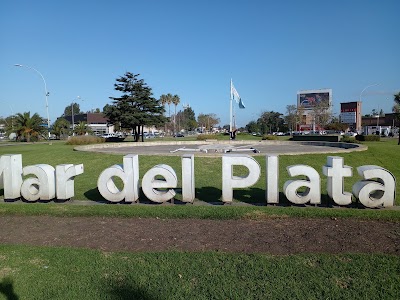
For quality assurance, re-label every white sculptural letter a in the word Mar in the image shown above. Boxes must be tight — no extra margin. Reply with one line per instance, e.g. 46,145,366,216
21,164,56,201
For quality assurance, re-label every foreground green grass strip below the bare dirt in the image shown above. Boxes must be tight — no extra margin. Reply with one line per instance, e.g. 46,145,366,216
0,246,400,299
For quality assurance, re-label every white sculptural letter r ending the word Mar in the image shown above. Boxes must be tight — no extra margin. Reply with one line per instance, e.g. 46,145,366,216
56,164,83,200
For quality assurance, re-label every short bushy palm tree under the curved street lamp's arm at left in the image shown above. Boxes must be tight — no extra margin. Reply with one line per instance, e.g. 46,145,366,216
14,111,45,142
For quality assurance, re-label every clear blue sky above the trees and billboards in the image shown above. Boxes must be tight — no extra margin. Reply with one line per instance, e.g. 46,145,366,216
0,0,400,126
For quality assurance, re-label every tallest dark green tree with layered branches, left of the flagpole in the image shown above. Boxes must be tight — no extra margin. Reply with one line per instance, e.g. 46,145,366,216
104,72,167,142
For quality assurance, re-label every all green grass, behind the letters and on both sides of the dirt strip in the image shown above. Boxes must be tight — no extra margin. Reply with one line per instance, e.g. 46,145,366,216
0,139,400,299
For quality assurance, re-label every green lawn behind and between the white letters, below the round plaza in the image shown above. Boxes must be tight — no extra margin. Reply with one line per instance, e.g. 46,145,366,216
0,139,400,216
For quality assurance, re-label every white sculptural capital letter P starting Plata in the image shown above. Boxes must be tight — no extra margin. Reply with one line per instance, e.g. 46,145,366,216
222,155,261,203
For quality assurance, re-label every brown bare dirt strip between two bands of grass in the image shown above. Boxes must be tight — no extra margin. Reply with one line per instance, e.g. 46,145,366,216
0,216,400,255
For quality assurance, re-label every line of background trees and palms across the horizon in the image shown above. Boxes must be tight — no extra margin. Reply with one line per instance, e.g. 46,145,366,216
0,72,400,143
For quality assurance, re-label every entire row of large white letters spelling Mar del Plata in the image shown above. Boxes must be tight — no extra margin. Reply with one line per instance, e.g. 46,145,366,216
0,154,396,208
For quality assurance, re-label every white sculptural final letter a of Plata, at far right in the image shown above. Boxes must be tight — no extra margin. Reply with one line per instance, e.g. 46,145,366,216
353,166,396,208
